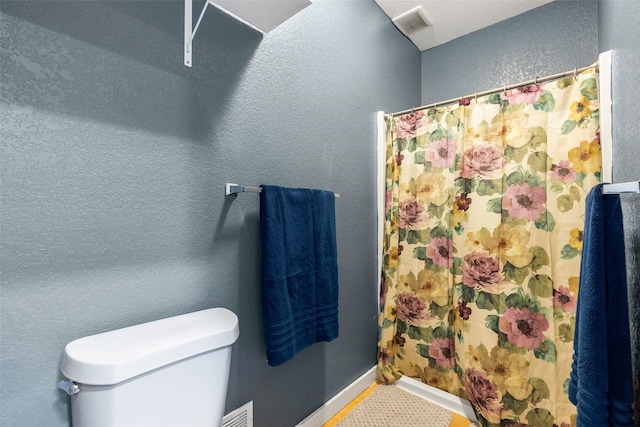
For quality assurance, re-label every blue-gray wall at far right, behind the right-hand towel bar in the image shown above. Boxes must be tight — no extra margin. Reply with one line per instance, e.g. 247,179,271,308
598,0,640,425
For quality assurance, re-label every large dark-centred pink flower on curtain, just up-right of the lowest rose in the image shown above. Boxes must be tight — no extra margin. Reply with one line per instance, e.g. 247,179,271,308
498,307,549,350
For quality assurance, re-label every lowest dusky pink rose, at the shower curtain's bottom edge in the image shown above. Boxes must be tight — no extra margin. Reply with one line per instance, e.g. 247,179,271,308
463,369,502,424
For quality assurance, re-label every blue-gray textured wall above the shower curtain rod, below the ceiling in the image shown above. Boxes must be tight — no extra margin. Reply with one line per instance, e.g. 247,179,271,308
422,0,598,105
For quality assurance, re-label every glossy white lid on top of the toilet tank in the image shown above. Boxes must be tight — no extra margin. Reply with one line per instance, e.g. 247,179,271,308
61,308,239,385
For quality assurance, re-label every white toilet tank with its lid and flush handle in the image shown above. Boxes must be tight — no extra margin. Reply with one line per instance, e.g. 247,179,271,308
61,308,239,427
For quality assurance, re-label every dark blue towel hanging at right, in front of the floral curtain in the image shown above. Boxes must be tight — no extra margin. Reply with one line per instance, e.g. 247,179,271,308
569,184,634,427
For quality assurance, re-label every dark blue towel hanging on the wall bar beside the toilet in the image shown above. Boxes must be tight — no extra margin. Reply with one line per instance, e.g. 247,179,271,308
260,185,338,366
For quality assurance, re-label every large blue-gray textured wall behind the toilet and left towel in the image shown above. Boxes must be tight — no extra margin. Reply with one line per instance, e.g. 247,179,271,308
0,0,420,427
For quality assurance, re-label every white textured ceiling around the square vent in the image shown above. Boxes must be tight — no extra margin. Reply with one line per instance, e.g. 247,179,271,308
374,0,553,51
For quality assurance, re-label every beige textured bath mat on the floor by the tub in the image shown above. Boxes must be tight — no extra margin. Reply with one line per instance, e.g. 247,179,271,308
332,384,453,427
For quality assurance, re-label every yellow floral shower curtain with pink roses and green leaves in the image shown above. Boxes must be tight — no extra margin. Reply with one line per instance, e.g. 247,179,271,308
378,68,601,427
